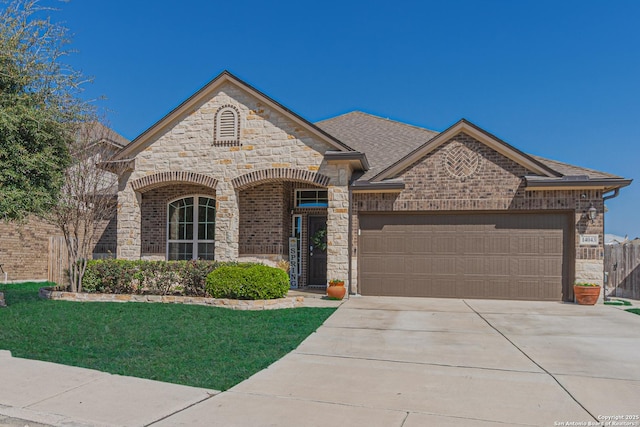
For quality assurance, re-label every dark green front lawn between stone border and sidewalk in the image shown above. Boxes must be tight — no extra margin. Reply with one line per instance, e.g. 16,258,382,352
0,283,335,390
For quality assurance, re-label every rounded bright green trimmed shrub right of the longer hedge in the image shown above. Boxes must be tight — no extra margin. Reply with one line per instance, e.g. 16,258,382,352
207,264,289,300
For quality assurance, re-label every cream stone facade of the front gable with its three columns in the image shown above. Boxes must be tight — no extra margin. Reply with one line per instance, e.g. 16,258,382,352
118,83,351,288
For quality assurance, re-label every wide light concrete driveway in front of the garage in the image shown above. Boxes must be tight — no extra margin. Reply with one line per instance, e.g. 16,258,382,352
161,297,640,427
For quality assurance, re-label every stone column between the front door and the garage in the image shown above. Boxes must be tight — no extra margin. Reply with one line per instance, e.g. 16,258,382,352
327,164,351,286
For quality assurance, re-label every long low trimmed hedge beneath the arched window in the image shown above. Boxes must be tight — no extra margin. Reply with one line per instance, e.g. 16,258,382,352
82,259,220,296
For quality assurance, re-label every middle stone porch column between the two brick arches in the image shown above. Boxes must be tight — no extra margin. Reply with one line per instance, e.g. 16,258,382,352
215,182,240,261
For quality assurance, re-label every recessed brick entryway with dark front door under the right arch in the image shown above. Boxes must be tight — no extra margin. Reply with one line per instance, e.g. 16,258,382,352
236,169,329,288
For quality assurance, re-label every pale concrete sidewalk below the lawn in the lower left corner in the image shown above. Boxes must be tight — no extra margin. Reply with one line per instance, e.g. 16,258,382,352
0,351,218,426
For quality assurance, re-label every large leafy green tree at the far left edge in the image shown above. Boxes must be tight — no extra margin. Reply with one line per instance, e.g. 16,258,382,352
0,0,95,220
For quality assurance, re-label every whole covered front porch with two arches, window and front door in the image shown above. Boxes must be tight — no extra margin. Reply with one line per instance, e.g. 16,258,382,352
118,168,348,288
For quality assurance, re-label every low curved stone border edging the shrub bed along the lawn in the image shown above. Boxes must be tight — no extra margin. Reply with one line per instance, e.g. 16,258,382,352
38,287,304,310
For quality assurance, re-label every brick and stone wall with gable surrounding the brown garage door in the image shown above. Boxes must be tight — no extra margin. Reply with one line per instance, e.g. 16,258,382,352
351,133,604,291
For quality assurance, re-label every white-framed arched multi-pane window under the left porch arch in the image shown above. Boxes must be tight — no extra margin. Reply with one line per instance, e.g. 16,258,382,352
167,196,216,260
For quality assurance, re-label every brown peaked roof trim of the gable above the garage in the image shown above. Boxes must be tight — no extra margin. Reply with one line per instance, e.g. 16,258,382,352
370,119,562,182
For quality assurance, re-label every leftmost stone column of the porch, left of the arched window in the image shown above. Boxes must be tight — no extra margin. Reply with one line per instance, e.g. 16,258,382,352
117,179,142,260
